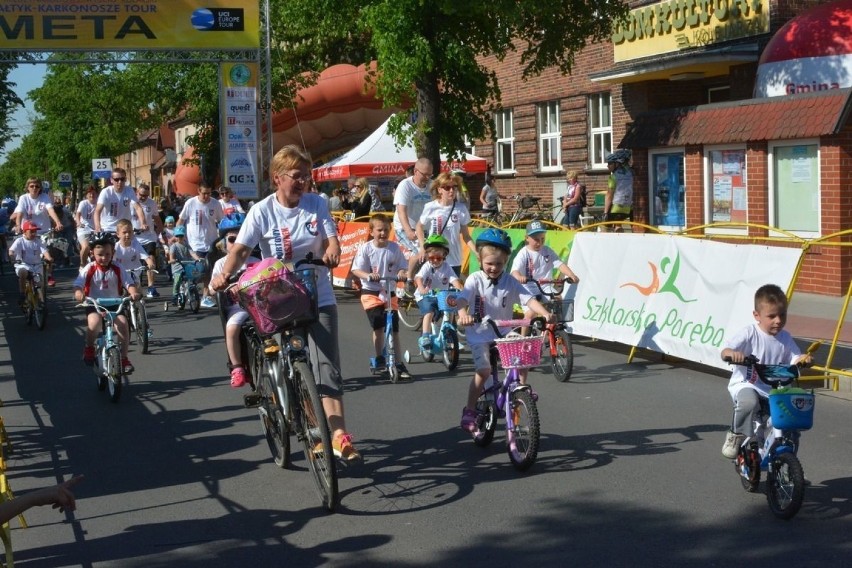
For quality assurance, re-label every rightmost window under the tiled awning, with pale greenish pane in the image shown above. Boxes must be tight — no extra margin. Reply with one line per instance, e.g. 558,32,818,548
769,141,820,237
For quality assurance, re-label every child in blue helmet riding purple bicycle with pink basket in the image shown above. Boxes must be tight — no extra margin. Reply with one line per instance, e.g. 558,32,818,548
457,229,554,432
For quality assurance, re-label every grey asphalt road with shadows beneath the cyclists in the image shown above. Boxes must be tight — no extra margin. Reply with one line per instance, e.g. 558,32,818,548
0,273,852,568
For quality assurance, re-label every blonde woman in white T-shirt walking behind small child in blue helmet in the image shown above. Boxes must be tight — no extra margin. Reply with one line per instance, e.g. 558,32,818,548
415,172,476,276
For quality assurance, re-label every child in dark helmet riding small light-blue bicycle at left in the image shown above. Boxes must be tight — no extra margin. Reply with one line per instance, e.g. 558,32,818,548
74,232,142,375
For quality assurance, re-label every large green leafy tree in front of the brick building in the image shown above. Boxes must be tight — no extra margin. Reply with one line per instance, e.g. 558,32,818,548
273,0,627,169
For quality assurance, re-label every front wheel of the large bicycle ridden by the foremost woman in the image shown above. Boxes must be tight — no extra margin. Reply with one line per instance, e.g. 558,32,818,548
295,361,338,511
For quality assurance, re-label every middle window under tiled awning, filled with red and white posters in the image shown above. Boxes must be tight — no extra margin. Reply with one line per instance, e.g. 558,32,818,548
704,147,748,233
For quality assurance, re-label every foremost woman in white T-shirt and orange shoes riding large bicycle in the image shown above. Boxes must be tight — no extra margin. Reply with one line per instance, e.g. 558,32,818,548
211,145,361,461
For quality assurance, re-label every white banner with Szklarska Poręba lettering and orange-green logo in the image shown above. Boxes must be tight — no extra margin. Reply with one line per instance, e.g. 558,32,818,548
568,232,802,368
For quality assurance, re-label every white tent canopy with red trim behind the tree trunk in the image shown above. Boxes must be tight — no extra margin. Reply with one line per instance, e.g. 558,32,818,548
313,119,488,182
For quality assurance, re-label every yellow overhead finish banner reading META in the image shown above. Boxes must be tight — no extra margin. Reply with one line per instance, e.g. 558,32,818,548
0,0,260,51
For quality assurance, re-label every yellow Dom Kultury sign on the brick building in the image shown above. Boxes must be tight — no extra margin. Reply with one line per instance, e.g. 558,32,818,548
612,0,769,63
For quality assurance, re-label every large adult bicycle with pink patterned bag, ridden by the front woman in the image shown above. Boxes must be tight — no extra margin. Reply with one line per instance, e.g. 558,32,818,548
229,258,339,511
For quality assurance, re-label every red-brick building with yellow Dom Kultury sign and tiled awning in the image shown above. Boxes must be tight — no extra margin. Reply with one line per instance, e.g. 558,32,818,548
474,0,852,295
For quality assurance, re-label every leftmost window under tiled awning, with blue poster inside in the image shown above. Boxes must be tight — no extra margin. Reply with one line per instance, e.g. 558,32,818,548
650,153,686,229
